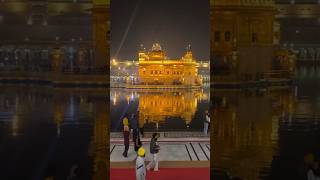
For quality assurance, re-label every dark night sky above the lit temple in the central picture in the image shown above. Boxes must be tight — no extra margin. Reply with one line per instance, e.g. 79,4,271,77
111,0,210,60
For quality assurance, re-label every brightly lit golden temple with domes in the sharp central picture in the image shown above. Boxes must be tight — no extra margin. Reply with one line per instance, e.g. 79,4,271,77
139,43,201,86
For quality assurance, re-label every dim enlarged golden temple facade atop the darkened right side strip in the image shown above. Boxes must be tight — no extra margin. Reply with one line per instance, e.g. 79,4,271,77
210,0,277,79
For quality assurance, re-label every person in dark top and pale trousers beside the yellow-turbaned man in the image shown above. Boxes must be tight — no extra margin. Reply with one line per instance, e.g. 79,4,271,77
147,133,160,171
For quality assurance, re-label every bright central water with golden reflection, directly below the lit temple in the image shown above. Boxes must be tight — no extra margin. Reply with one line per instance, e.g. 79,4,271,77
110,88,210,132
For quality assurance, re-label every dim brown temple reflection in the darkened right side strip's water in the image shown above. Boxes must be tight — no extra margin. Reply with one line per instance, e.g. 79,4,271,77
211,88,295,180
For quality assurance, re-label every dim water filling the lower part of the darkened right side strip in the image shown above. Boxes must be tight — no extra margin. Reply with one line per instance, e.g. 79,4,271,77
211,67,320,180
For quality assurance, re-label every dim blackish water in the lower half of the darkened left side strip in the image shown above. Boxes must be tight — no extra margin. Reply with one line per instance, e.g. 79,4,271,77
0,86,108,180
